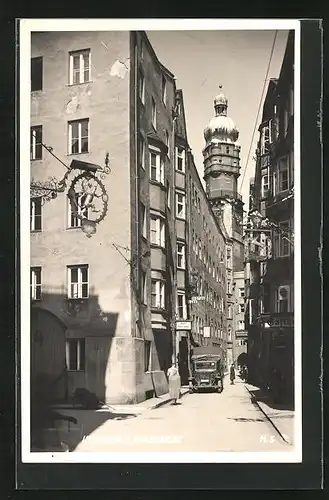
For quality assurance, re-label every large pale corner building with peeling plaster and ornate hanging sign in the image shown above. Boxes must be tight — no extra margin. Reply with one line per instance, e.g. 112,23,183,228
31,32,186,403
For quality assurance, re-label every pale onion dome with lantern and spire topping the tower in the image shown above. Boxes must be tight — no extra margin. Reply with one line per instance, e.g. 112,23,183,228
204,85,239,143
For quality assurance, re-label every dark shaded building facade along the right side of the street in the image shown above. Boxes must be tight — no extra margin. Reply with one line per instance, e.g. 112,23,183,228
246,32,294,402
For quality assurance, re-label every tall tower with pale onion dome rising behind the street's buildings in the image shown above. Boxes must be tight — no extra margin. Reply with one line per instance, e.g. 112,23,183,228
203,85,244,271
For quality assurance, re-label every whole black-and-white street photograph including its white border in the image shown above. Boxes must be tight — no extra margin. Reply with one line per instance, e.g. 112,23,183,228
19,19,302,463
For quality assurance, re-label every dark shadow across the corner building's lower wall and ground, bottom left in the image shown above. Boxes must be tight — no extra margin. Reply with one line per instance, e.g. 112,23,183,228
30,293,120,450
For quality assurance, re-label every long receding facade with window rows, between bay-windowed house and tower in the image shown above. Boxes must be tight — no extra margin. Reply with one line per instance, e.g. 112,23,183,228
184,152,228,366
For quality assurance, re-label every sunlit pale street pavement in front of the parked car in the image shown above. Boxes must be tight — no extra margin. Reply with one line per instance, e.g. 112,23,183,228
73,378,291,452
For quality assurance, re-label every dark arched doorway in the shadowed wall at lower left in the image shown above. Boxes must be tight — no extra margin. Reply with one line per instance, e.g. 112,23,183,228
31,308,67,403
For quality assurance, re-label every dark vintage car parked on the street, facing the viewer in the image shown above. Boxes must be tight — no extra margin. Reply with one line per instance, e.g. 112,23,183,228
189,346,224,393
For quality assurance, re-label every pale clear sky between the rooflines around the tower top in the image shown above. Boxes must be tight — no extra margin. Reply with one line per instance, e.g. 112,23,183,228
147,30,288,207
